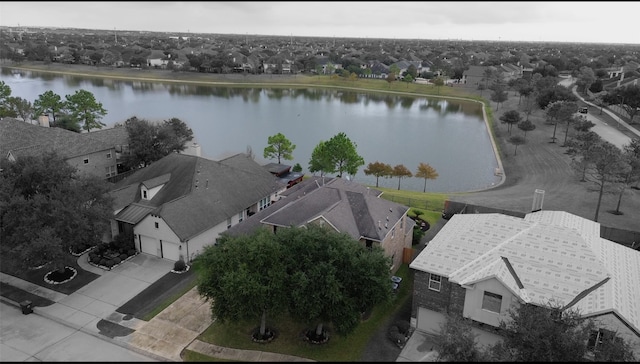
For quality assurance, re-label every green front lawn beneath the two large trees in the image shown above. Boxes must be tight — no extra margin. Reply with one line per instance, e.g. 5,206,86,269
198,264,413,362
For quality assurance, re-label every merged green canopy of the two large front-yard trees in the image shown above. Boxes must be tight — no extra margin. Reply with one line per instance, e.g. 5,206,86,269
198,224,391,335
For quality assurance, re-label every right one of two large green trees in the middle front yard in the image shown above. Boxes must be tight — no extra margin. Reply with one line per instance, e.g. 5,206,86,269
275,224,391,337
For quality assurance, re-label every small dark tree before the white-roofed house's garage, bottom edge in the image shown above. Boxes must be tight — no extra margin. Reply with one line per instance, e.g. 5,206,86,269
435,314,490,362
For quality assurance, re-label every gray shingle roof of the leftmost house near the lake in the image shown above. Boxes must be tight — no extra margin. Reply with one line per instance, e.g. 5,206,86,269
0,118,113,159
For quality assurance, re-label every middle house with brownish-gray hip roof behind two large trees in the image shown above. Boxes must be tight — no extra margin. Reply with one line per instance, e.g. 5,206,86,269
227,176,415,272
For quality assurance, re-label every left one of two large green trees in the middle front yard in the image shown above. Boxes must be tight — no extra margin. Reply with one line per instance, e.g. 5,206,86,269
198,228,287,338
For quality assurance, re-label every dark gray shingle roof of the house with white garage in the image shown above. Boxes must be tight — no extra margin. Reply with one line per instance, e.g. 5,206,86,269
111,153,282,241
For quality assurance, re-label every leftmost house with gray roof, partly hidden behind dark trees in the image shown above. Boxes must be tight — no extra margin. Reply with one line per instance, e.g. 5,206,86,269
0,116,118,179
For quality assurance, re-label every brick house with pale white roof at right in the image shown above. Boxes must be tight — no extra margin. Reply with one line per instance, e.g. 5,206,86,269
410,210,640,357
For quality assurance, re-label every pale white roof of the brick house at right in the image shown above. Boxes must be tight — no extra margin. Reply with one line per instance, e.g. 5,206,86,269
410,211,640,332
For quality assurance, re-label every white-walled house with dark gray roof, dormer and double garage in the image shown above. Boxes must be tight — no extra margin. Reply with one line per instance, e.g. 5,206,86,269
106,153,286,262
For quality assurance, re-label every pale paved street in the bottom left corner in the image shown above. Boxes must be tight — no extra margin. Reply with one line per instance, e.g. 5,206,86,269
0,302,156,362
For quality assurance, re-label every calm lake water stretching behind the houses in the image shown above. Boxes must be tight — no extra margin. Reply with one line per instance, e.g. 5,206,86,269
0,69,499,192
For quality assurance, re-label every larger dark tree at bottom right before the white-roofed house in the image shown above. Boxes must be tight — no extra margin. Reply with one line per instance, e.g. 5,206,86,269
488,301,633,362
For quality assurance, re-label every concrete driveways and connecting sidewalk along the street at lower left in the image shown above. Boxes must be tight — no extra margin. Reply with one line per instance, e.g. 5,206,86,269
0,254,313,362
